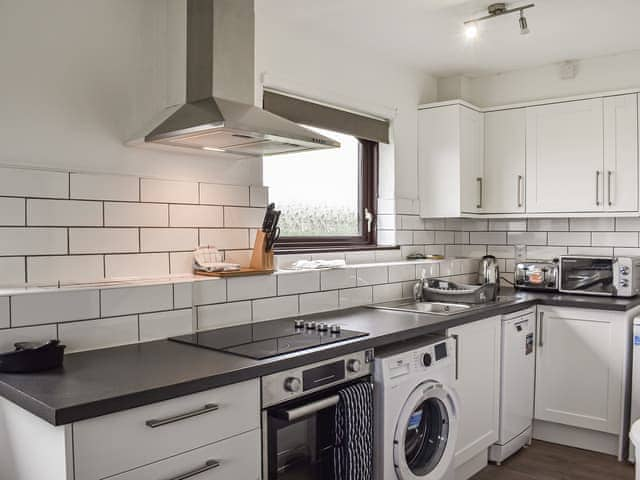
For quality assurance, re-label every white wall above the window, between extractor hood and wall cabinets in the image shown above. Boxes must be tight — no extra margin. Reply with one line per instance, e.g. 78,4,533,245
256,0,436,199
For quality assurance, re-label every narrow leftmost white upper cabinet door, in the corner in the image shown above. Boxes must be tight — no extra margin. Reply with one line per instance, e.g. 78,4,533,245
460,107,487,213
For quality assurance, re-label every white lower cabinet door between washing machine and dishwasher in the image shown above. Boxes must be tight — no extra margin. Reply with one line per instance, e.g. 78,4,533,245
447,316,501,467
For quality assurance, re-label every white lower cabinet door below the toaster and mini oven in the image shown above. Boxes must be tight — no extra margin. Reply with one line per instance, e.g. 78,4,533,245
535,307,629,434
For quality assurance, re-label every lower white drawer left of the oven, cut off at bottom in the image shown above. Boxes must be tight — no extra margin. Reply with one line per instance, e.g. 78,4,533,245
109,430,260,480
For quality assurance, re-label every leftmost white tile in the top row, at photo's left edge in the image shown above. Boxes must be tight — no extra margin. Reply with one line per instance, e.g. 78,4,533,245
0,168,69,198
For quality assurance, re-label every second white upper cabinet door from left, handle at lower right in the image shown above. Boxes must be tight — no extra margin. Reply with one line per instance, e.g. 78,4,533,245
484,108,526,213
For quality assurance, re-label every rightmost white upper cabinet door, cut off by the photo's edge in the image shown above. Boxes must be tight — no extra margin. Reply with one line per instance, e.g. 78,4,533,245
604,94,638,212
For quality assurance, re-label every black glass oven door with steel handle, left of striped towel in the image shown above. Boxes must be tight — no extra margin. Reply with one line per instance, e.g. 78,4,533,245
262,377,371,480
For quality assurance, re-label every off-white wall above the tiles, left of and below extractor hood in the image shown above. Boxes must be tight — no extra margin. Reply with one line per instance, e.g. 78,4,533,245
0,0,261,184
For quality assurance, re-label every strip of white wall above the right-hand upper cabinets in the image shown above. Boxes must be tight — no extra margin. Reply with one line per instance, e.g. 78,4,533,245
456,51,640,106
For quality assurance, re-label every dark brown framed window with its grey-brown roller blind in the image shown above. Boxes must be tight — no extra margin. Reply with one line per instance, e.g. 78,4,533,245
263,91,388,252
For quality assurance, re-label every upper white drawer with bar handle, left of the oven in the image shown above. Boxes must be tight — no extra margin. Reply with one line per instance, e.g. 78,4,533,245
73,379,260,480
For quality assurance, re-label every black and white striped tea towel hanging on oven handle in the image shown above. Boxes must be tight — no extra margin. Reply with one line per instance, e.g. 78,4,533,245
333,382,373,480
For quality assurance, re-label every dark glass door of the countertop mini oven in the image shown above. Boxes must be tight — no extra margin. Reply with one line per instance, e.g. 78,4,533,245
560,257,616,296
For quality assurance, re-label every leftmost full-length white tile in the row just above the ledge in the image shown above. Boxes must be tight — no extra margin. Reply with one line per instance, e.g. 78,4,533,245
27,255,104,284
